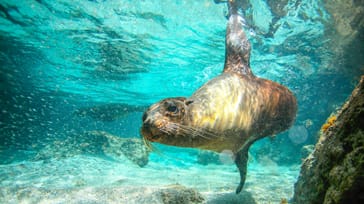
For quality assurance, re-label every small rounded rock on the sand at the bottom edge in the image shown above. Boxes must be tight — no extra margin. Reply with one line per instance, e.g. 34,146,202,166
157,185,205,204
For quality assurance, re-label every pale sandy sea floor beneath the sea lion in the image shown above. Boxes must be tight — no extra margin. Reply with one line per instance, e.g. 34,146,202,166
0,152,299,204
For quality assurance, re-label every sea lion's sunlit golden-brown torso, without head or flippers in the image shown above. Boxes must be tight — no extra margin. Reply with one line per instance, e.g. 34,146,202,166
187,73,296,153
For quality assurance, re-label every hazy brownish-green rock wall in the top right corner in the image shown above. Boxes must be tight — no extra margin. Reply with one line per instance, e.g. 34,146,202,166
320,0,364,79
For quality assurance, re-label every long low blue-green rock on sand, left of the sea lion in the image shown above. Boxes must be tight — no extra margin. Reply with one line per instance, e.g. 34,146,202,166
33,131,149,167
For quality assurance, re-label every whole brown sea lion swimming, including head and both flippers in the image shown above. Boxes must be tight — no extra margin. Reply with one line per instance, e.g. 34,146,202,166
141,0,297,193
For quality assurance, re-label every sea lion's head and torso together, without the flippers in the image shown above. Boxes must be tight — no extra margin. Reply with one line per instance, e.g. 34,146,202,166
142,73,297,153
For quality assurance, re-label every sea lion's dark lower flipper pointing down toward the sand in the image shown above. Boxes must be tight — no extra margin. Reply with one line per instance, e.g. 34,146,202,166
235,148,249,194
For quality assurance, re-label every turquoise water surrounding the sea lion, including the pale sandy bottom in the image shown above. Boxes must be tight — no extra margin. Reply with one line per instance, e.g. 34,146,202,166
0,0,364,203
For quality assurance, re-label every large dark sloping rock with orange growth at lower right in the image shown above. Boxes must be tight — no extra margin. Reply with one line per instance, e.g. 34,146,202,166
293,76,364,204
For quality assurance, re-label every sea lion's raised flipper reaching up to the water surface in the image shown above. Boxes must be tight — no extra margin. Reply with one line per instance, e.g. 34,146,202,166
223,0,254,76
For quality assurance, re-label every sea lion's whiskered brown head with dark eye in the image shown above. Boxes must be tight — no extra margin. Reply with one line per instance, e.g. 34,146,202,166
141,97,191,145
